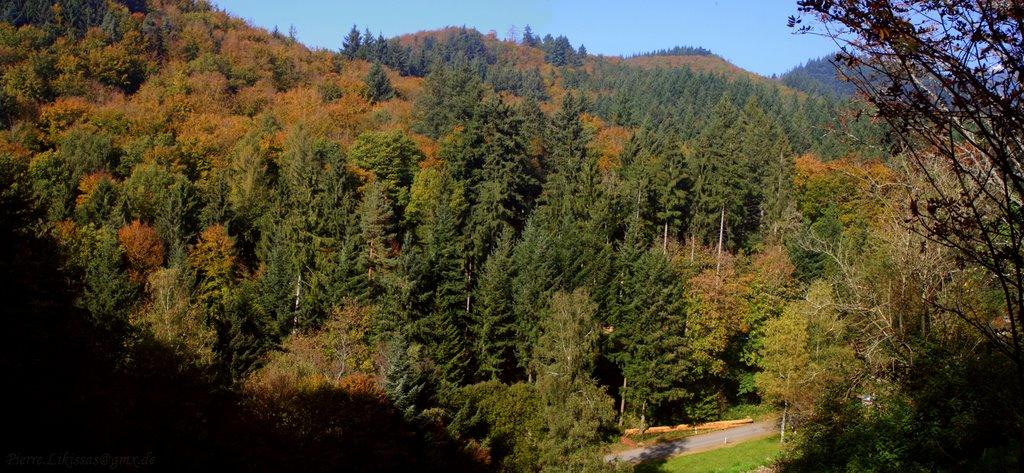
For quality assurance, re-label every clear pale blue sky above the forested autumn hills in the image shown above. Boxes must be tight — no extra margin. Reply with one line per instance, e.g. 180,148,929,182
213,0,836,76
